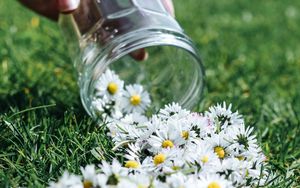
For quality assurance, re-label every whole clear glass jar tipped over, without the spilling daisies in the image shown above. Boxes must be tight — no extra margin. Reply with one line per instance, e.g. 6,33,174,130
59,0,203,118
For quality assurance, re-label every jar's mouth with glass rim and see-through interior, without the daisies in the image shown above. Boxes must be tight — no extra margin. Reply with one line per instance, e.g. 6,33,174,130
79,28,204,118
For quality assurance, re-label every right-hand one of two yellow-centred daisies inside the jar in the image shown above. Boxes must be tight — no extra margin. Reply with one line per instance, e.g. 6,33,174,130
121,84,151,113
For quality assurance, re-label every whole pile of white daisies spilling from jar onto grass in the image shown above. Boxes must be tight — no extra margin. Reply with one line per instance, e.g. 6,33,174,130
50,70,269,188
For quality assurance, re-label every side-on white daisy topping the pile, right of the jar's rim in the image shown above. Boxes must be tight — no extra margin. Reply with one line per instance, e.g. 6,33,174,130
205,102,244,133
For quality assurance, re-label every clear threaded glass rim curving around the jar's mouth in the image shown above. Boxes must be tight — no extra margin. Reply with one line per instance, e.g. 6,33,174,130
79,28,204,117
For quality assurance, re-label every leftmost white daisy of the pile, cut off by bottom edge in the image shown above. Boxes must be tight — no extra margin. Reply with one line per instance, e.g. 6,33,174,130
49,172,83,188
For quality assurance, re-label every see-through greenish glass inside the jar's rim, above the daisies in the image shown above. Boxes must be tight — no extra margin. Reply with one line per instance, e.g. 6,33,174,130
102,46,203,113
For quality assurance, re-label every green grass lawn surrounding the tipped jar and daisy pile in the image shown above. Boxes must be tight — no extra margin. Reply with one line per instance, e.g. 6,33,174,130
0,0,300,187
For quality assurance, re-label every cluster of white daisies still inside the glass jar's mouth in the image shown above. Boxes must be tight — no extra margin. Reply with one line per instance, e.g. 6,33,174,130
92,69,151,118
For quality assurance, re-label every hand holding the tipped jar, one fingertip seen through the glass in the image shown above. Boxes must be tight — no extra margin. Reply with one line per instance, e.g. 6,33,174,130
19,0,175,61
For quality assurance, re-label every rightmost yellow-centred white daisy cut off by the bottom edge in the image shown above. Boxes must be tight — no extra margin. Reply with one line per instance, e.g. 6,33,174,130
198,174,233,188
